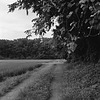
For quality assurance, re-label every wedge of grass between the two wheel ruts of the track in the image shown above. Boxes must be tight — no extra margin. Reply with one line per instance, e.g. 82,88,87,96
15,70,53,100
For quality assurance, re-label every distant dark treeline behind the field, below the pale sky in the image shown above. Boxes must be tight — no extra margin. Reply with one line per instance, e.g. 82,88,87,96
0,38,62,59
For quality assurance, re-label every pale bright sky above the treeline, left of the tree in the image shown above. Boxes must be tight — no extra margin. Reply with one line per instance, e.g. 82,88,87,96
0,0,51,40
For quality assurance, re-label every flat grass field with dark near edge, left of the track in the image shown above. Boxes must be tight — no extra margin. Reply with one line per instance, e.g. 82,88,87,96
0,60,46,82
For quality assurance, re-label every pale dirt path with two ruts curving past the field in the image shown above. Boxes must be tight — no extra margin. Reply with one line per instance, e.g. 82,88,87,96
0,61,64,100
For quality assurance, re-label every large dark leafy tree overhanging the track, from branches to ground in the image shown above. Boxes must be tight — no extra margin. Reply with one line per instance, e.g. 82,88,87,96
9,0,100,61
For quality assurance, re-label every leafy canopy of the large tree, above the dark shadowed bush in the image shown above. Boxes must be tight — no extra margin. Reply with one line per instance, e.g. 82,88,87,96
9,0,100,38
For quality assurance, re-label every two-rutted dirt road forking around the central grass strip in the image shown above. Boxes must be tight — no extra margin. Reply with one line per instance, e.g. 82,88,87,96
0,60,65,100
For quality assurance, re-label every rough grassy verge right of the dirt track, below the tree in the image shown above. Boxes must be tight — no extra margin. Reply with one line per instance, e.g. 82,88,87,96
60,63,100,100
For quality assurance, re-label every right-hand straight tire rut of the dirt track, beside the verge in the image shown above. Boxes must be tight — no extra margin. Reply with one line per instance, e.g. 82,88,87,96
50,64,63,100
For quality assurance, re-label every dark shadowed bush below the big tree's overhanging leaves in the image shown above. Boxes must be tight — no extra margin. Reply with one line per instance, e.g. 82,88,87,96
70,36,100,63
